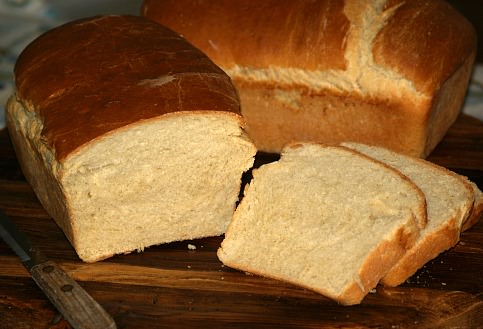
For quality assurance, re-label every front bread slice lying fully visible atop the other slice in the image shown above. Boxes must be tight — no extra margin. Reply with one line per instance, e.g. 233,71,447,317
218,143,425,305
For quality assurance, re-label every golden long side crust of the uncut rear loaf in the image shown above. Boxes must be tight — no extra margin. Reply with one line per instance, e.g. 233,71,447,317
233,78,430,156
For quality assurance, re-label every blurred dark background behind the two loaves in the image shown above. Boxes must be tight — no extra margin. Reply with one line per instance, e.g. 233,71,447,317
0,0,483,129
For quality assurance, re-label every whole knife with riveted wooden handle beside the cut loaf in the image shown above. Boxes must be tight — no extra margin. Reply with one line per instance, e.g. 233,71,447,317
0,210,116,329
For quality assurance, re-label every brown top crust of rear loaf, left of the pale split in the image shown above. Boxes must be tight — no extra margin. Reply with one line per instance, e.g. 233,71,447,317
143,0,349,70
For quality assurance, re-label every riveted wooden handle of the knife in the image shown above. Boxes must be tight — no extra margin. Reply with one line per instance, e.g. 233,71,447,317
30,261,116,329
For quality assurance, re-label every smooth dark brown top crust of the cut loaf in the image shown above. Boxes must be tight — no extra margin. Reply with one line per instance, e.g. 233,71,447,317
15,16,239,159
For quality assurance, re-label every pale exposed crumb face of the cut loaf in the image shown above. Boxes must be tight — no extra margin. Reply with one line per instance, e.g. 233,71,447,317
62,112,256,261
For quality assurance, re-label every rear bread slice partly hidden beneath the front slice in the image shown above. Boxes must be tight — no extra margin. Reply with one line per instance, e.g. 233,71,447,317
342,143,474,286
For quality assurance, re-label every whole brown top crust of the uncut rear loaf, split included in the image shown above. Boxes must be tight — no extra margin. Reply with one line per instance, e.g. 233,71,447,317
143,0,476,95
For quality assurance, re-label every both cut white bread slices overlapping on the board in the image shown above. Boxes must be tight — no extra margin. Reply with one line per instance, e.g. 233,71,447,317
218,143,483,305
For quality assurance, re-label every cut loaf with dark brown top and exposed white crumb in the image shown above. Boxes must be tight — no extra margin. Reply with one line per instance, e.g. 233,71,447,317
6,16,256,262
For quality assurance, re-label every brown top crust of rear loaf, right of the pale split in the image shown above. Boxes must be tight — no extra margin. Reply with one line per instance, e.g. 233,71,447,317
373,0,476,95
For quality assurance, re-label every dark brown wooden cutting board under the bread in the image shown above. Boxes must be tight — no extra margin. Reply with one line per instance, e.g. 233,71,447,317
0,116,483,329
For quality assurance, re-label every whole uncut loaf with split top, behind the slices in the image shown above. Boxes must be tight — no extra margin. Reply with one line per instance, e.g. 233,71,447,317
143,0,476,157
